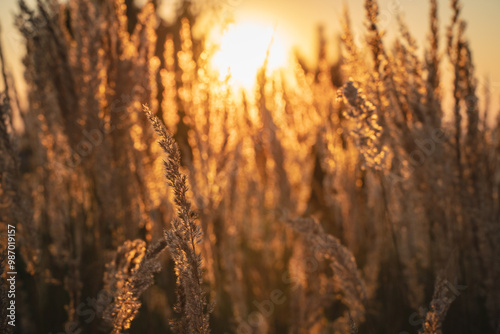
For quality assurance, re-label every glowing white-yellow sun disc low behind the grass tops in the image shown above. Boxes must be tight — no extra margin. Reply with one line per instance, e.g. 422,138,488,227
212,22,287,89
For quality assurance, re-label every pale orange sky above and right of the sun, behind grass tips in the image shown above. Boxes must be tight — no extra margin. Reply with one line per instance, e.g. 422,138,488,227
218,0,500,88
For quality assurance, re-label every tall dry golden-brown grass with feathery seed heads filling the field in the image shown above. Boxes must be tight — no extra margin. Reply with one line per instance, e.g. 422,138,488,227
0,0,500,333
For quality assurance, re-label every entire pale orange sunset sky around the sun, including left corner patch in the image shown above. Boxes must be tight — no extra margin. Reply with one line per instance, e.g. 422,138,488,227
0,0,500,113
